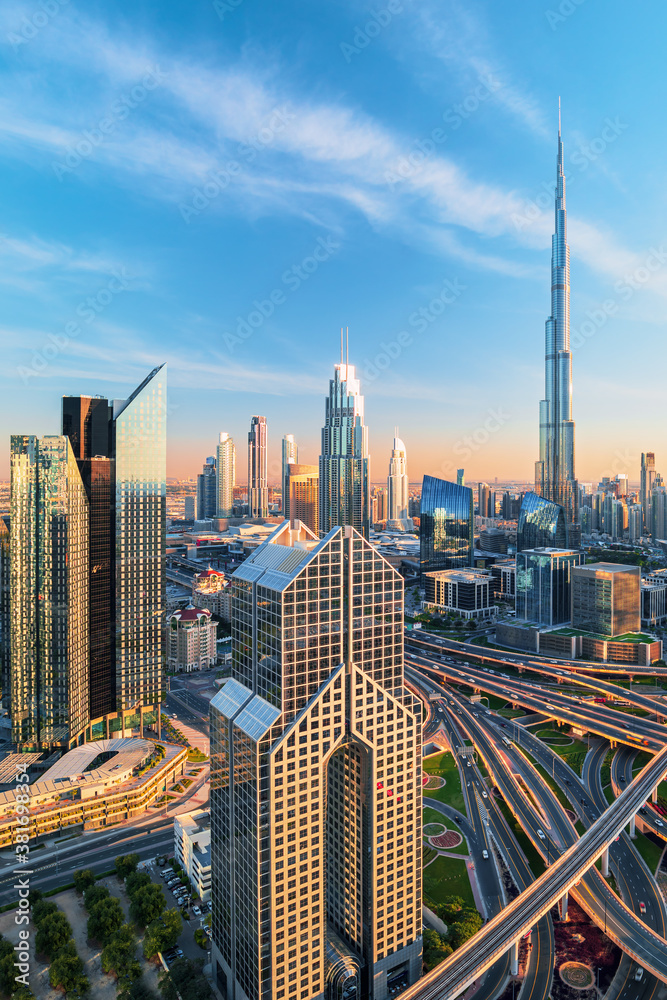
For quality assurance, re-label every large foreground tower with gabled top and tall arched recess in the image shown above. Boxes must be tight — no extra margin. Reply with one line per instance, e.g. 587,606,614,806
210,522,422,1000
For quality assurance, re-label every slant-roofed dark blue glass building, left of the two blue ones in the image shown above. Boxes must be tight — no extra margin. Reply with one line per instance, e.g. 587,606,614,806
419,476,474,573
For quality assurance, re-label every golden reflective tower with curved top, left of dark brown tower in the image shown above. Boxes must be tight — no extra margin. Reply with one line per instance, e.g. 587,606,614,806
10,435,89,747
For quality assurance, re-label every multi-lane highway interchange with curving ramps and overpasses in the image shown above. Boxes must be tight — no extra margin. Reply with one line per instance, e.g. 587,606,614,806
404,633,667,1000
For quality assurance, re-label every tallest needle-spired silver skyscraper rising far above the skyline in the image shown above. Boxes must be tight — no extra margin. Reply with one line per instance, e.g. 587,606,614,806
535,111,578,542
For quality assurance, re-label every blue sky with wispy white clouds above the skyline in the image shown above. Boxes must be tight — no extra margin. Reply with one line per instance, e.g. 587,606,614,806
0,0,667,480
